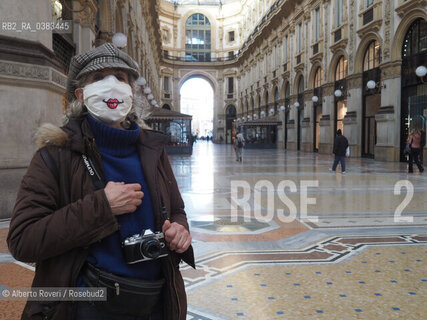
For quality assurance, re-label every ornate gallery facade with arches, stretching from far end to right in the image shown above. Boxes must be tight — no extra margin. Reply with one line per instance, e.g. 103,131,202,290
160,0,427,161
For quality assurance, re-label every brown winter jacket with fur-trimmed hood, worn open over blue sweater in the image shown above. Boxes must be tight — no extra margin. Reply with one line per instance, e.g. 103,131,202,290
7,117,194,320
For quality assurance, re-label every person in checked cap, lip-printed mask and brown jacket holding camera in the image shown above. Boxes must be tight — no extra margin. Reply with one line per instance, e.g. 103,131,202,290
7,43,194,320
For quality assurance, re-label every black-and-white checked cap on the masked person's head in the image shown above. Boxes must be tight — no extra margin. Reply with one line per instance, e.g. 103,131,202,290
67,43,139,99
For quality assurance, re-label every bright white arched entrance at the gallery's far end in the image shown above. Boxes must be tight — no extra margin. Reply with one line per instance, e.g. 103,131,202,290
180,76,214,138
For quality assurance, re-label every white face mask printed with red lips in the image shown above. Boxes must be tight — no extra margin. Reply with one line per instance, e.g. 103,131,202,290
83,75,133,124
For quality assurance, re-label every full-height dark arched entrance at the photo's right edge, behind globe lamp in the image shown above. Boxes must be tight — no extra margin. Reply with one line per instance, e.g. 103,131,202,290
400,18,427,161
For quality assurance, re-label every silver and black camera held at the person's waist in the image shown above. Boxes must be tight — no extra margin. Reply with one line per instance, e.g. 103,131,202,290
122,229,169,264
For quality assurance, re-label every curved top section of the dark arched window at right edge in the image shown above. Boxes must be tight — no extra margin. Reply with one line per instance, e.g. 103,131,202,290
402,18,427,57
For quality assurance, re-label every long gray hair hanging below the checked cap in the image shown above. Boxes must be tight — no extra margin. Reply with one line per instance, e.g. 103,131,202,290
62,73,153,129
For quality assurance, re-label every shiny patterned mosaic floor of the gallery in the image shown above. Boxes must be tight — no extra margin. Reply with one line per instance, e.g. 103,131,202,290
0,142,427,320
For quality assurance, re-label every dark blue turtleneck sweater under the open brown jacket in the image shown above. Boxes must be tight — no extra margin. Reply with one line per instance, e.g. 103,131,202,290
83,115,161,280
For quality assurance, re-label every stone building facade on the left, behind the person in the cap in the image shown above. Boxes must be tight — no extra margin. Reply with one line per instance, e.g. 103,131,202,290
0,0,161,218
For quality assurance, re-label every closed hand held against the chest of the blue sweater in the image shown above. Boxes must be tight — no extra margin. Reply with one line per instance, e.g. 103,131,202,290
104,181,144,215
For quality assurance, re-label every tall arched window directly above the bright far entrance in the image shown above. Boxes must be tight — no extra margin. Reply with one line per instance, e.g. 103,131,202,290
185,13,211,61
